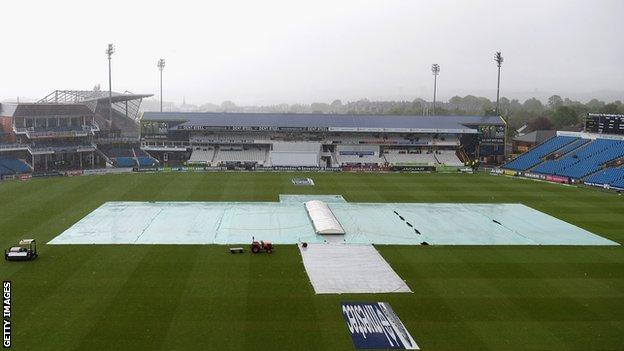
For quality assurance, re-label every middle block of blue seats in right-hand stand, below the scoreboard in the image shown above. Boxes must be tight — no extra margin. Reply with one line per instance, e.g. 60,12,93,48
533,139,624,179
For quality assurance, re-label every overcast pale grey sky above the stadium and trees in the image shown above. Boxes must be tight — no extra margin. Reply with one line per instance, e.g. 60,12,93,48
0,0,624,104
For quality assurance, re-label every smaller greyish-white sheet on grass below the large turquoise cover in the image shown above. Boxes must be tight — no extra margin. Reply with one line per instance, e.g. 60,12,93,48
299,244,412,294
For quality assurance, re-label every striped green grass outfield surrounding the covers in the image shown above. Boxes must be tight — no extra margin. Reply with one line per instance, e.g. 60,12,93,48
0,173,624,350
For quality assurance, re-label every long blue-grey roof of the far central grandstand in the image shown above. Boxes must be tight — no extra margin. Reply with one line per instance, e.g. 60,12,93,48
142,112,505,133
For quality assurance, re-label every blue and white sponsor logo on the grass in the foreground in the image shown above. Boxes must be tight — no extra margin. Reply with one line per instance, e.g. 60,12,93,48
342,302,420,350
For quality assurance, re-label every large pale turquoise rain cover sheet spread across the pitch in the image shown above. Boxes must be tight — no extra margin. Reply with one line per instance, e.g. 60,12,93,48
50,202,618,245
